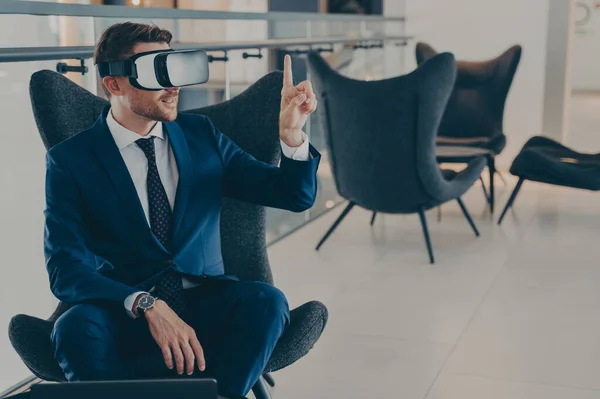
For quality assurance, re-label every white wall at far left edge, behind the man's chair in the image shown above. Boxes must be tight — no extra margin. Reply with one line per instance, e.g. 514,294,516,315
0,16,65,392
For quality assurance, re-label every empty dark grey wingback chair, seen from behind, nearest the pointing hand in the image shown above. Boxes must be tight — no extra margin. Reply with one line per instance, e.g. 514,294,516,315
308,53,485,263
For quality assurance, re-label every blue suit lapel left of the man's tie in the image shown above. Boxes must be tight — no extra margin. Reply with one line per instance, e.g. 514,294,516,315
93,113,166,251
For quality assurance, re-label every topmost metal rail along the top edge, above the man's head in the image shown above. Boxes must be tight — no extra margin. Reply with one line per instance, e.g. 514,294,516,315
0,0,404,22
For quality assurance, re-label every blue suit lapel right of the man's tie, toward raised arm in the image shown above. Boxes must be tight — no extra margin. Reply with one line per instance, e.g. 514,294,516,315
164,122,192,243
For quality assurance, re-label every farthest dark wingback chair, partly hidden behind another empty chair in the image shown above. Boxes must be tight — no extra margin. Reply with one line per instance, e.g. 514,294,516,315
415,43,522,212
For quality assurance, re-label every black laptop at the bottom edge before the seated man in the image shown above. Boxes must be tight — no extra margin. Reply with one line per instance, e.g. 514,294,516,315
31,379,217,399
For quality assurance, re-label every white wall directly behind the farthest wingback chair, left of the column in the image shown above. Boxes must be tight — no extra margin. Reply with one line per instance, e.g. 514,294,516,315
396,0,548,169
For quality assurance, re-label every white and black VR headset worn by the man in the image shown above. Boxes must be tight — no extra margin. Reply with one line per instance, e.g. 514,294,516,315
98,49,208,91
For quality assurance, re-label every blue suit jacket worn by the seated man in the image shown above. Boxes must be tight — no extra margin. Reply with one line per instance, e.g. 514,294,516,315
44,110,320,303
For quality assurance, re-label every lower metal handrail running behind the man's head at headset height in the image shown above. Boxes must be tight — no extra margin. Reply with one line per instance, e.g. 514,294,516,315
0,36,413,63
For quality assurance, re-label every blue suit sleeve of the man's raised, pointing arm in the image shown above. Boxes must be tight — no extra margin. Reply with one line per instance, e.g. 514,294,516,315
207,119,321,212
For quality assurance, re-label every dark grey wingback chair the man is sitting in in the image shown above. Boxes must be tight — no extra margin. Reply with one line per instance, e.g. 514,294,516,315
9,71,328,399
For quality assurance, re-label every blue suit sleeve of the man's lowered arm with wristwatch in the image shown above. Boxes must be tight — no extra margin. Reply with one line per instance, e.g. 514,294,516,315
44,152,139,304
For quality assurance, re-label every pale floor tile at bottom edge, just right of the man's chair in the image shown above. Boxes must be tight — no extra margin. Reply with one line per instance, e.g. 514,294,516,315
273,333,451,399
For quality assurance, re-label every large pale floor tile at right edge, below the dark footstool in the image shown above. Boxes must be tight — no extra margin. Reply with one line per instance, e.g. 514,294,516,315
448,247,600,389
